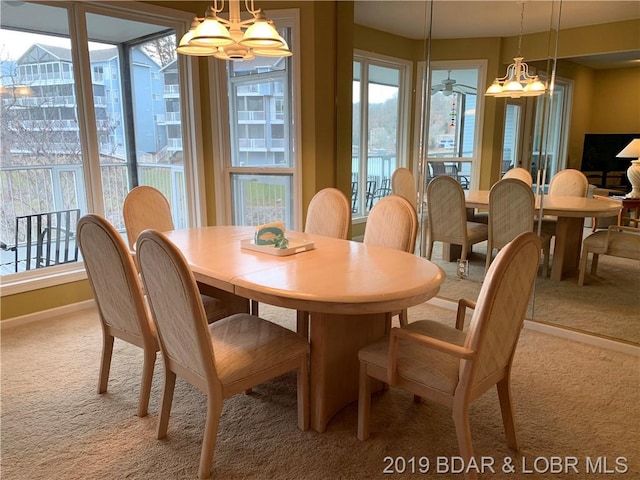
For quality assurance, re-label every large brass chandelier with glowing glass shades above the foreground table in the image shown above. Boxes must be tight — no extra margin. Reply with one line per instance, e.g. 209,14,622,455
176,0,292,60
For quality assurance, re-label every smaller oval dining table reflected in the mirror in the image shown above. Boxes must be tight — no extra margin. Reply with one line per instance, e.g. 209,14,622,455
465,190,621,281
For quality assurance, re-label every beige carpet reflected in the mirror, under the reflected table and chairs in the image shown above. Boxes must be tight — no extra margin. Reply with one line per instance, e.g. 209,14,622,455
420,229,640,345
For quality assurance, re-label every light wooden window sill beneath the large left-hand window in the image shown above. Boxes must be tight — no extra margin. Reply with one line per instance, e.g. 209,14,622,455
0,263,87,297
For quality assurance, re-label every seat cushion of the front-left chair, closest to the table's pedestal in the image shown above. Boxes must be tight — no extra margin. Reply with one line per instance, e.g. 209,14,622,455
209,313,309,385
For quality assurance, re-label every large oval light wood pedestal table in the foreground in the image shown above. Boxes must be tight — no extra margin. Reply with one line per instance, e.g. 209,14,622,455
166,226,445,432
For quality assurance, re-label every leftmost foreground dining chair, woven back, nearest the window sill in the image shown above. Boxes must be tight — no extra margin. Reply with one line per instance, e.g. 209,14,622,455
77,214,160,417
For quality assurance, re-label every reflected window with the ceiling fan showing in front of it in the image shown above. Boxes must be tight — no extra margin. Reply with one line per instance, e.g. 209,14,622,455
418,61,486,189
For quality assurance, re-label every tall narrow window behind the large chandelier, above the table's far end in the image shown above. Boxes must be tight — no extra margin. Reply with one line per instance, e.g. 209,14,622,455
210,10,301,229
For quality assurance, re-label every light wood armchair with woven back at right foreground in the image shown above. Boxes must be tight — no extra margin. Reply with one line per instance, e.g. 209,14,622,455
357,232,540,479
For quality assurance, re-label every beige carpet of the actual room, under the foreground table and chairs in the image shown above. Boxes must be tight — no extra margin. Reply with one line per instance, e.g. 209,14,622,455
1,305,640,480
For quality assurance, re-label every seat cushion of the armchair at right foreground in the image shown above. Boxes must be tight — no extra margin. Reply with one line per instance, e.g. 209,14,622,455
358,320,466,394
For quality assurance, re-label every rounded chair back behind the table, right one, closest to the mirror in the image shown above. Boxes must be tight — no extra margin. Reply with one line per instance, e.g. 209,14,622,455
363,195,418,253
